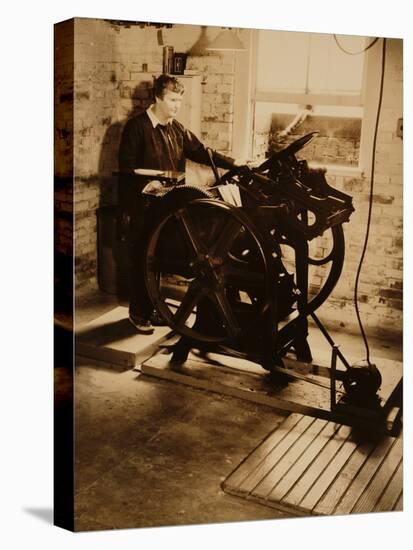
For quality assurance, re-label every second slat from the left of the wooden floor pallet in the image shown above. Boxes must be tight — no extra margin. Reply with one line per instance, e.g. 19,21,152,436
240,416,315,493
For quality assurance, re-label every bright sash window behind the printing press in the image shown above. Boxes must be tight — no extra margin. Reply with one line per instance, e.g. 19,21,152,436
252,30,369,168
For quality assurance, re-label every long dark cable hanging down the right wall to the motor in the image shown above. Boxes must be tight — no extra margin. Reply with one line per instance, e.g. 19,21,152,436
354,38,386,365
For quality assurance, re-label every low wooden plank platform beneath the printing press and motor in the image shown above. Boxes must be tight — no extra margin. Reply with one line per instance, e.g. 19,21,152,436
140,349,402,434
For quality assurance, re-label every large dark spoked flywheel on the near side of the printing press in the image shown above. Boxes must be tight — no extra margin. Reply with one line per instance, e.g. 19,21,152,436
144,188,275,342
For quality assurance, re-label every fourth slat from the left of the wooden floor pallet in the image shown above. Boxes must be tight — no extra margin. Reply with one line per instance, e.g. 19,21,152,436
268,422,339,501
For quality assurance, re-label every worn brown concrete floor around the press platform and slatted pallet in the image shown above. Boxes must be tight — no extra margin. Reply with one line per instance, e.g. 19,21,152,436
69,293,401,531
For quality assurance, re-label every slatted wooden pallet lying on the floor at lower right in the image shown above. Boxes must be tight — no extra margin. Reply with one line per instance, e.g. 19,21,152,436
223,413,403,515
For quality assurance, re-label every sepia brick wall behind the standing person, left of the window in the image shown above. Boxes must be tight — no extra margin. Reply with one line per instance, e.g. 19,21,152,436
67,19,234,287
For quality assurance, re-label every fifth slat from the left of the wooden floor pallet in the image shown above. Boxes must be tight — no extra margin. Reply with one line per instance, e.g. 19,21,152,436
283,426,351,506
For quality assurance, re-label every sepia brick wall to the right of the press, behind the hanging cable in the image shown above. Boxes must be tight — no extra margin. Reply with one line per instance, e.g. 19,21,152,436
331,40,403,336
